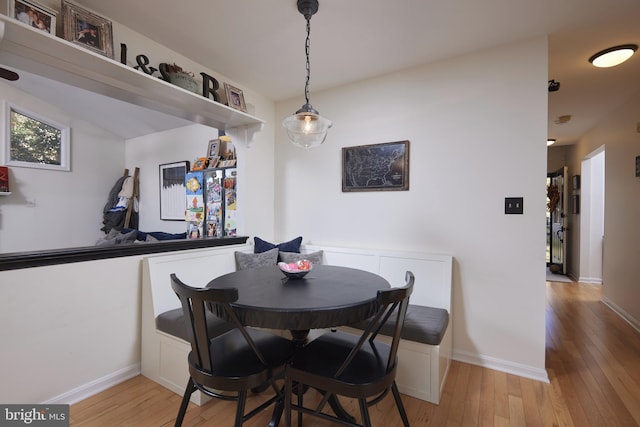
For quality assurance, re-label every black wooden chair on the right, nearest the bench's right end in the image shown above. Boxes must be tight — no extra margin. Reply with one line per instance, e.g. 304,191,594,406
284,271,415,427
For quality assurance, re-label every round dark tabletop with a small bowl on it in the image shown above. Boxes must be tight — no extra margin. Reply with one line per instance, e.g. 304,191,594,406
207,265,390,330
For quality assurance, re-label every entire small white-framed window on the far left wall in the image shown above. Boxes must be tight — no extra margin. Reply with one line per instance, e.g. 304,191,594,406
5,105,70,171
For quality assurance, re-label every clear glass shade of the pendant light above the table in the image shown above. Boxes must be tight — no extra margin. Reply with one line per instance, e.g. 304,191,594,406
282,104,333,148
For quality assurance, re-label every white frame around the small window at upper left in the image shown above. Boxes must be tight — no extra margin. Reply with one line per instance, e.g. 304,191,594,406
3,102,71,172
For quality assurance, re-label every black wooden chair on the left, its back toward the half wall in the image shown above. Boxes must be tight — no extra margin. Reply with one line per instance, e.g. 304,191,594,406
171,274,295,427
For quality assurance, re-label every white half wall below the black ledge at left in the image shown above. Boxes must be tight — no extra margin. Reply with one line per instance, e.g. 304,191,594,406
0,257,142,403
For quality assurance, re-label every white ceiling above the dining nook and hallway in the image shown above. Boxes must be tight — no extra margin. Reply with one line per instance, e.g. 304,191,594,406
71,0,640,145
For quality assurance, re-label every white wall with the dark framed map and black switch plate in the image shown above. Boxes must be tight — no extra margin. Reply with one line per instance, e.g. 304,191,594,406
276,38,548,379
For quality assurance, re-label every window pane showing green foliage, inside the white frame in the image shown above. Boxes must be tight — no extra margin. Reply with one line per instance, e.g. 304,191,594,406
10,109,62,166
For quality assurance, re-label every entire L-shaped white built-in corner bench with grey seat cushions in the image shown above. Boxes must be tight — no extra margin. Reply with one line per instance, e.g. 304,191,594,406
142,245,453,405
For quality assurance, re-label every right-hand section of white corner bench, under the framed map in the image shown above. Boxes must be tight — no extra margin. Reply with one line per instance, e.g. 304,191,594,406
302,245,453,404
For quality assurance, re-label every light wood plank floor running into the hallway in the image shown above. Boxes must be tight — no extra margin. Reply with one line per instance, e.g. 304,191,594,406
71,282,640,427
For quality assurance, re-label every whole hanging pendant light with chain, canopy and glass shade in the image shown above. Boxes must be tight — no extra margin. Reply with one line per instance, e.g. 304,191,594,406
282,0,332,148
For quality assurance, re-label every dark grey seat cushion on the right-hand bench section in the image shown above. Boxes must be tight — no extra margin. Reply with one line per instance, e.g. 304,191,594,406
351,304,449,345
